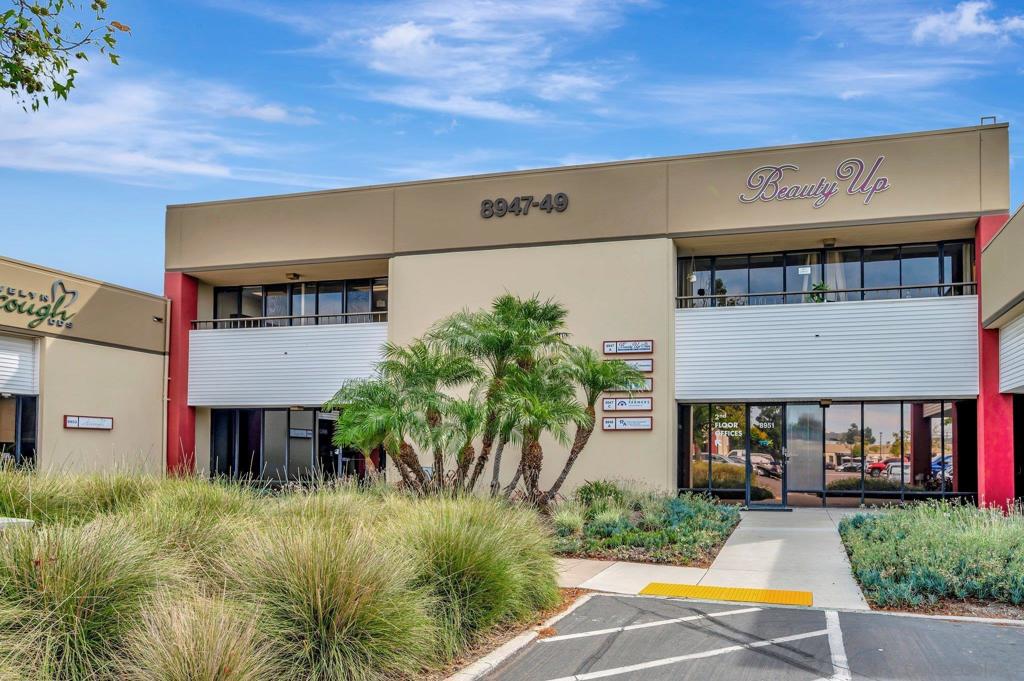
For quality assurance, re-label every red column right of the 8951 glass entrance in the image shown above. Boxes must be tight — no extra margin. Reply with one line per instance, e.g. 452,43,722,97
974,215,1014,509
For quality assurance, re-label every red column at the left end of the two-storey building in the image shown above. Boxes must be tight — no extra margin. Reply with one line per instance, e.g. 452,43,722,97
164,272,199,474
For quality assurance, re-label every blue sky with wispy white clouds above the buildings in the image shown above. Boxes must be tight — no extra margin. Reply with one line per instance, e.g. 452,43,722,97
0,0,1024,292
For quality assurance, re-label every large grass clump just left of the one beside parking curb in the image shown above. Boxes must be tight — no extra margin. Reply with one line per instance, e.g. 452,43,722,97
222,516,436,681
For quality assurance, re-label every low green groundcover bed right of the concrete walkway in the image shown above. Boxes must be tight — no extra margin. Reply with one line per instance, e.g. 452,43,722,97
840,502,1024,607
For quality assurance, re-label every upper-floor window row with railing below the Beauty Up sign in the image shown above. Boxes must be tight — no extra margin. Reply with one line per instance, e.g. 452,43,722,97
678,241,975,307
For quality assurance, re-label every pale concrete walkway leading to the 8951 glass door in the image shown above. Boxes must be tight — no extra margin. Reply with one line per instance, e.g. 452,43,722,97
559,508,868,610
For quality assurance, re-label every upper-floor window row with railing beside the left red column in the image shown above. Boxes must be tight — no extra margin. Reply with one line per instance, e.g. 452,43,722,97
206,278,388,329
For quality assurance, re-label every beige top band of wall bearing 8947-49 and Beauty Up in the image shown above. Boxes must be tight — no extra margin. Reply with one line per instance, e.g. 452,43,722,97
166,124,1010,271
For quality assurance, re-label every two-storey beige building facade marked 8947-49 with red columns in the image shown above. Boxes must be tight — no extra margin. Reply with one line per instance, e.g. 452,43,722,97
166,125,1024,505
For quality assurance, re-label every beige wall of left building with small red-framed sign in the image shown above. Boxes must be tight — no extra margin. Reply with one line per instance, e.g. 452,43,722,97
37,337,166,474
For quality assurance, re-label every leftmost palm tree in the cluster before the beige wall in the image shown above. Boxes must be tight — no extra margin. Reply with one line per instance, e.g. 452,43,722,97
324,377,427,492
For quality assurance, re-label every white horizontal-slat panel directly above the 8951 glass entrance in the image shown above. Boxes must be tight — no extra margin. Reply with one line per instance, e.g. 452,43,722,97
675,292,978,401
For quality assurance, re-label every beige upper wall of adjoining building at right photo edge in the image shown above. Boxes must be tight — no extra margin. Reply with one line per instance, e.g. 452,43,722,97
981,207,1024,327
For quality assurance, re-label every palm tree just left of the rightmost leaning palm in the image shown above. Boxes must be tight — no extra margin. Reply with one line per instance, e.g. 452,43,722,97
507,355,592,502
